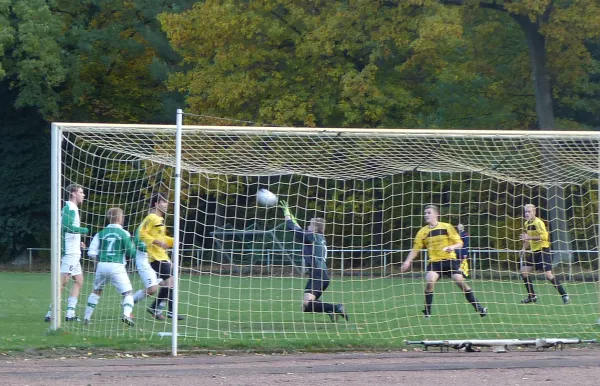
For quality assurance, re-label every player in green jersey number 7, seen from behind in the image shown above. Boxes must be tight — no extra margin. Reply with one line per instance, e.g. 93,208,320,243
83,208,135,326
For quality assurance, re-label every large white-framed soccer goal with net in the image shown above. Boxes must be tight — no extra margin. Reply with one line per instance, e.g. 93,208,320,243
52,112,600,352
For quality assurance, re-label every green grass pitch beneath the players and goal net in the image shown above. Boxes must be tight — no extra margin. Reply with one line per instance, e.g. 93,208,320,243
0,272,600,352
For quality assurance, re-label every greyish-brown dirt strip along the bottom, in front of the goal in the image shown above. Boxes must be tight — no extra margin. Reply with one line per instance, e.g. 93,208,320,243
0,347,600,386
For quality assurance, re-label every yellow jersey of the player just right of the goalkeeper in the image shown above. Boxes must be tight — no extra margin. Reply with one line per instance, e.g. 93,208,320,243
413,222,462,262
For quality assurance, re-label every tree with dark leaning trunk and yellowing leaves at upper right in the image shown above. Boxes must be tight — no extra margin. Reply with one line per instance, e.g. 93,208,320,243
435,0,600,130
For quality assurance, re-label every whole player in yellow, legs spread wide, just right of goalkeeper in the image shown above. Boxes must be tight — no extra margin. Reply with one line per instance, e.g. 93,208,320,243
401,205,487,318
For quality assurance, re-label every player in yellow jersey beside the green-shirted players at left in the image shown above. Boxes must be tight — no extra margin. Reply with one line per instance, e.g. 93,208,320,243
139,194,183,320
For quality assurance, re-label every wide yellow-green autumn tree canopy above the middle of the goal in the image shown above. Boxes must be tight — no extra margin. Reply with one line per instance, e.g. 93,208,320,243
159,0,426,127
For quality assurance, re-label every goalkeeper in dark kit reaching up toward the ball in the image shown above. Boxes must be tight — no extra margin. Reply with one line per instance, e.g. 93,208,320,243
280,201,348,322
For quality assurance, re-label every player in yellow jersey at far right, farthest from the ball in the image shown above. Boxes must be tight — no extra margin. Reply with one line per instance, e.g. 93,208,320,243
520,204,571,304
